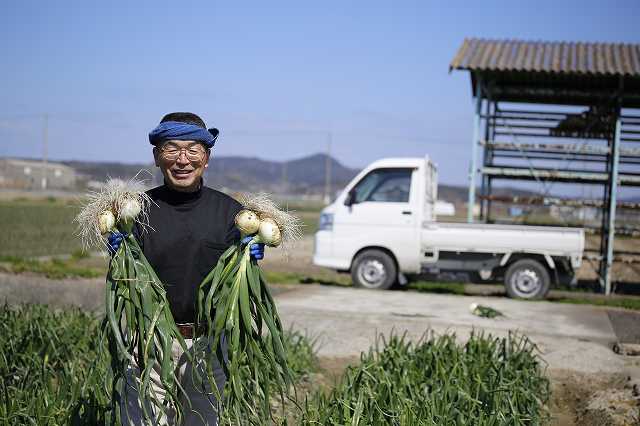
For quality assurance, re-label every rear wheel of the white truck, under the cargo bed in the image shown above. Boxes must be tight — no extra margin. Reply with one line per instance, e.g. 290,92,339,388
504,259,551,299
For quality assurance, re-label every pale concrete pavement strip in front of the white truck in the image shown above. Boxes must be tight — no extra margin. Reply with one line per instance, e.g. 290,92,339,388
276,285,625,373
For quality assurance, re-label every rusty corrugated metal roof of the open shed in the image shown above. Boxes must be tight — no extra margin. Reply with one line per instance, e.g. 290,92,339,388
450,38,640,77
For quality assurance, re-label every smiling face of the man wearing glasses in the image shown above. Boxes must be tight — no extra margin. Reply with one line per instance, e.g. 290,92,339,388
153,140,209,192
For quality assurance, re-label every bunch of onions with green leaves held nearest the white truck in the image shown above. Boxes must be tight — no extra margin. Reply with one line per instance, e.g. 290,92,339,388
197,194,300,424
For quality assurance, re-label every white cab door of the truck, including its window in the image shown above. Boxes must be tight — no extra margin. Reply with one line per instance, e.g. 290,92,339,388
333,168,421,272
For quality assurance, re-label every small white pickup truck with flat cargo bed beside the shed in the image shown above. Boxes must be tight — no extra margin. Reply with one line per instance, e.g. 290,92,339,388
313,157,584,299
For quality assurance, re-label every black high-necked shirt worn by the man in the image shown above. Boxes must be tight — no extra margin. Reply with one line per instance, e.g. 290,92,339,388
136,185,242,323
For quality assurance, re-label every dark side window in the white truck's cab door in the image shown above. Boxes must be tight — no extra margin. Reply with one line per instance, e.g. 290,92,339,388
354,169,412,203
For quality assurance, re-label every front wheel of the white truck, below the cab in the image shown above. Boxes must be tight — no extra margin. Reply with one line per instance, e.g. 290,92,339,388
351,249,398,290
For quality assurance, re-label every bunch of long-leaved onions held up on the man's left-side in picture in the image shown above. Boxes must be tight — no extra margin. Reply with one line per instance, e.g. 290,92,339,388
76,179,186,423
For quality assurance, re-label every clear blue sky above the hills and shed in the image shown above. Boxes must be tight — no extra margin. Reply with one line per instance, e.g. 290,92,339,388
0,0,640,184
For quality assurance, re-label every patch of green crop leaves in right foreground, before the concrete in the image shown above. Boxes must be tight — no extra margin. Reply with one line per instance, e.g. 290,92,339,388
297,334,551,426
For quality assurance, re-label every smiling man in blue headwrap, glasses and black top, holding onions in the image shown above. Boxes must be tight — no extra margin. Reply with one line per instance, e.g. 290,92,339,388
109,112,264,426
